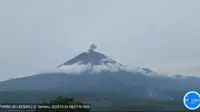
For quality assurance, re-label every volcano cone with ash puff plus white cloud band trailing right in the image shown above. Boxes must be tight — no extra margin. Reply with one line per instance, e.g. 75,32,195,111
57,44,153,74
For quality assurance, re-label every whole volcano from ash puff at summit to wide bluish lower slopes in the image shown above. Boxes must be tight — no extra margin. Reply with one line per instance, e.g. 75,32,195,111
0,45,200,110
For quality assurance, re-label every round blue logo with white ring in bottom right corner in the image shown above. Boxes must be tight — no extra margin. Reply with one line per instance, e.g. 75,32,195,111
183,91,200,110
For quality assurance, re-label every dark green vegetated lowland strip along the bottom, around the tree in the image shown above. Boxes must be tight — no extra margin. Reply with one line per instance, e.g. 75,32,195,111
0,91,196,112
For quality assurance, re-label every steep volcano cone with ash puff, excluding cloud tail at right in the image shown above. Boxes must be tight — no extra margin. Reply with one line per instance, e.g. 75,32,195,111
57,44,128,72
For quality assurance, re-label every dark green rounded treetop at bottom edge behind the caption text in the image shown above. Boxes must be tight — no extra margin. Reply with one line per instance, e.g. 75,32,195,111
36,96,90,112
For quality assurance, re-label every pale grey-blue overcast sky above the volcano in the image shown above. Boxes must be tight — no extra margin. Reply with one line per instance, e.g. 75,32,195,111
0,0,200,80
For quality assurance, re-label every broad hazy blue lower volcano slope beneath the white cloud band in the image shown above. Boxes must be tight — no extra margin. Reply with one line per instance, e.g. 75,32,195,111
0,72,200,99
